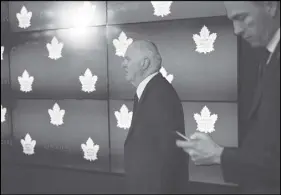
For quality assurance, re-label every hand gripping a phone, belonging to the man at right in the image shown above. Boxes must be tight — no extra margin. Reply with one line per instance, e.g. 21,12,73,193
176,132,223,165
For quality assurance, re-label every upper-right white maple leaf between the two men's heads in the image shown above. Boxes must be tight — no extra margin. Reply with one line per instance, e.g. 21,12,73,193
193,26,217,54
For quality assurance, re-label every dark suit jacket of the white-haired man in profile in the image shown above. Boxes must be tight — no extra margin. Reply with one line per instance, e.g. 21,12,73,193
124,74,188,194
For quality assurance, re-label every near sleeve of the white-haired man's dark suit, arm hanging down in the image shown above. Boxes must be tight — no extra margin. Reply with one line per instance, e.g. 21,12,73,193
142,91,188,193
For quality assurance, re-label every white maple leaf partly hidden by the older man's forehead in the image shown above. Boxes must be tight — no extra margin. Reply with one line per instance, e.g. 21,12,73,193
113,31,133,57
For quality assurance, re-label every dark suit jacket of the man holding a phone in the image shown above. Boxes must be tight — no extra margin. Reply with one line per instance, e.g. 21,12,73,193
221,43,280,193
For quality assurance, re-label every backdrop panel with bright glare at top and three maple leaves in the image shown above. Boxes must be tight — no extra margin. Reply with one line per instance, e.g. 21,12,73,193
10,27,107,99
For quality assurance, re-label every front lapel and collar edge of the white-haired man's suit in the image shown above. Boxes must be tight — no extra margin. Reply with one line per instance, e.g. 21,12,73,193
125,74,162,145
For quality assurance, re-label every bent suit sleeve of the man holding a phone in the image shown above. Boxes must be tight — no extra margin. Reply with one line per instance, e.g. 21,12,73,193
221,81,280,184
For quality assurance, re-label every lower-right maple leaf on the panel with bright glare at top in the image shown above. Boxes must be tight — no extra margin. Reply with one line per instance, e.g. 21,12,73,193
79,68,98,93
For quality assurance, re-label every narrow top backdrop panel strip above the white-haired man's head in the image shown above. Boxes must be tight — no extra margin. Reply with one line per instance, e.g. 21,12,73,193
107,1,226,24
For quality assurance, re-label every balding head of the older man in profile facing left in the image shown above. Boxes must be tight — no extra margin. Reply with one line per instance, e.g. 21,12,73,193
122,40,162,86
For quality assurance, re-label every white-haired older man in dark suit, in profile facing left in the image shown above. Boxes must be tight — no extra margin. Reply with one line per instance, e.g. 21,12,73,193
122,40,188,194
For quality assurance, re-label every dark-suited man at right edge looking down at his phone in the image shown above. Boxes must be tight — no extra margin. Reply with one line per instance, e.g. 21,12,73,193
177,1,280,194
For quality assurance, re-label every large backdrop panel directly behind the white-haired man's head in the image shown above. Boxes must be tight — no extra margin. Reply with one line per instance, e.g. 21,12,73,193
108,17,237,101
